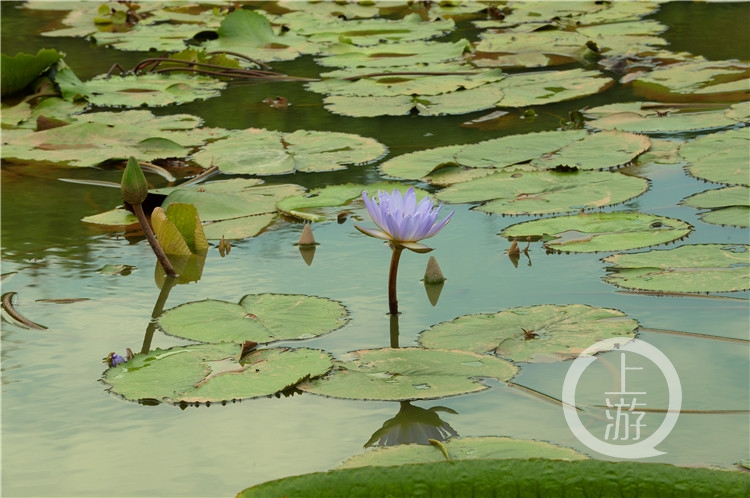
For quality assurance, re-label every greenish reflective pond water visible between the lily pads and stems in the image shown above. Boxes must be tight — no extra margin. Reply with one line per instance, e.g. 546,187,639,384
1,2,750,496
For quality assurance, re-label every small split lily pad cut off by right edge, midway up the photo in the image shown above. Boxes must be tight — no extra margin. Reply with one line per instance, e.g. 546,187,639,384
681,185,750,228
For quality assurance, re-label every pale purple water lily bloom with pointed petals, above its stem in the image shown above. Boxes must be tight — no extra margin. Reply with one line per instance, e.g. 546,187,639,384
354,187,453,253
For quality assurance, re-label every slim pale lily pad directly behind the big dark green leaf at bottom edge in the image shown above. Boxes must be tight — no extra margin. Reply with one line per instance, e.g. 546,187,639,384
337,436,588,469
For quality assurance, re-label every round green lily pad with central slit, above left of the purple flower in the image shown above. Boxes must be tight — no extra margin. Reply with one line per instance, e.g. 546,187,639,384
193,128,386,175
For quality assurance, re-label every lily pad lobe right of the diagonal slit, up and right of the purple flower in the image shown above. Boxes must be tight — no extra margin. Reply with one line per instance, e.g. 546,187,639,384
531,131,651,169
